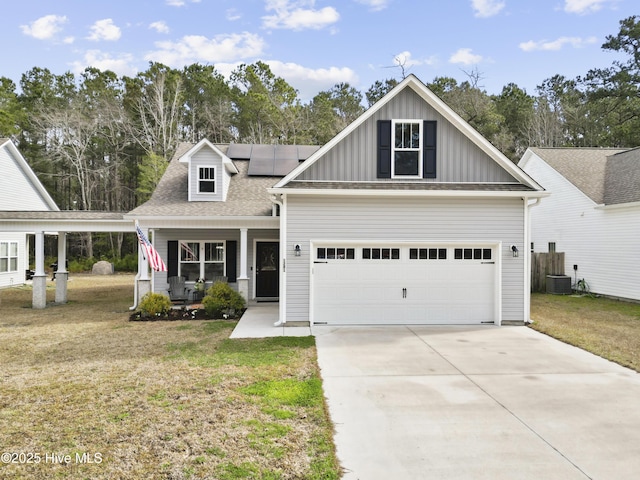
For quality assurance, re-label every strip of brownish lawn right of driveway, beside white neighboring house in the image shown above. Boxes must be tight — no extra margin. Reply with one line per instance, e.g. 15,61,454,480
531,294,640,372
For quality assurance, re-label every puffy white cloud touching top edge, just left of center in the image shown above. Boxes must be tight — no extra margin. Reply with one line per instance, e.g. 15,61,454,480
262,0,340,30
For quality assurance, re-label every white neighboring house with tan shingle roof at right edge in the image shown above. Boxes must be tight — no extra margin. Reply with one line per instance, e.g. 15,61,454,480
519,148,640,300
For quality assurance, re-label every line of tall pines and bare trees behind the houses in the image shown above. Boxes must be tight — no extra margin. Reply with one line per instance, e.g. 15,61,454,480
0,16,640,255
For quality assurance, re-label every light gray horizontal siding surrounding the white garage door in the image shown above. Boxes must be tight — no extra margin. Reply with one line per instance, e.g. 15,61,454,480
286,196,525,322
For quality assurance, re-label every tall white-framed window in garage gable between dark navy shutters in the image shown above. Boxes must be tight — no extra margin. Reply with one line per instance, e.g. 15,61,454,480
391,120,422,178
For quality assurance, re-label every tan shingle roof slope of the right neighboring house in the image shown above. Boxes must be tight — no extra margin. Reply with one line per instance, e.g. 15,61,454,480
531,147,628,204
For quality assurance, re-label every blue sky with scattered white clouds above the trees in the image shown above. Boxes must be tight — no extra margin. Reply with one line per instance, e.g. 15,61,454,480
0,0,640,101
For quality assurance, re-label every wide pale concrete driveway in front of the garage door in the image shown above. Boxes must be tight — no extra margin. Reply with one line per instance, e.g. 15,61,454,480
313,326,640,480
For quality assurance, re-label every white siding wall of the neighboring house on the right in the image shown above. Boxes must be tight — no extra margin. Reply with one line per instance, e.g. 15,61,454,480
525,155,640,300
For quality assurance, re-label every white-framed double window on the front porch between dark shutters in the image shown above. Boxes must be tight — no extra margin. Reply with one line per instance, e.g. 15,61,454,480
178,240,225,282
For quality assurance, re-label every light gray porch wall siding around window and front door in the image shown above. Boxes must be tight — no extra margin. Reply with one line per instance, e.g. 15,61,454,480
154,229,280,299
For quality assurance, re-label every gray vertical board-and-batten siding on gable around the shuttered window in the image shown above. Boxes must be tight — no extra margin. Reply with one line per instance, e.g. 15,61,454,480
297,88,516,183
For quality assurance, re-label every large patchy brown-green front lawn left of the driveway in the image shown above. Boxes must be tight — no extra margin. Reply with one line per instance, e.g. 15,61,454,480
0,275,340,480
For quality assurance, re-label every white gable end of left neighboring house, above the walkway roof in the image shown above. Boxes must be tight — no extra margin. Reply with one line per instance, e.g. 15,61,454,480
0,138,60,211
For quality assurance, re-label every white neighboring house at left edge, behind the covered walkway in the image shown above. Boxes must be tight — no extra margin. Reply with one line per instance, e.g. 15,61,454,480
0,138,59,288
